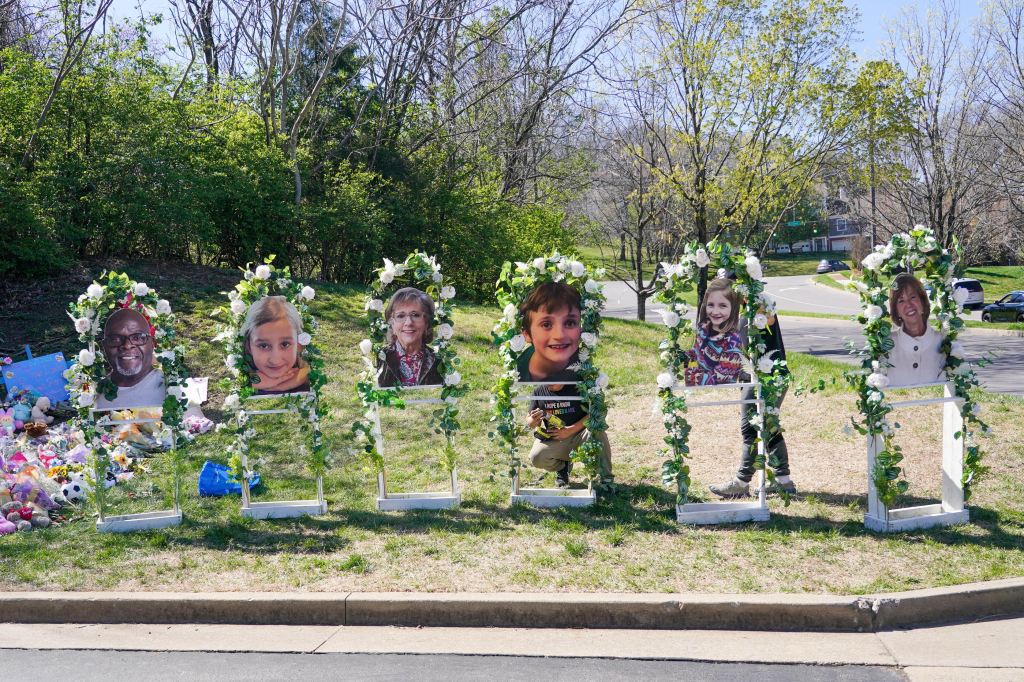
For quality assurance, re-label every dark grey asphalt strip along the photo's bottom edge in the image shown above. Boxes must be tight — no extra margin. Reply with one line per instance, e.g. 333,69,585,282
0,650,906,682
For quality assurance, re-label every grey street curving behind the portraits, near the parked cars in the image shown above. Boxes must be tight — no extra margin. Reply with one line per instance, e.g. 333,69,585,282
604,275,1024,395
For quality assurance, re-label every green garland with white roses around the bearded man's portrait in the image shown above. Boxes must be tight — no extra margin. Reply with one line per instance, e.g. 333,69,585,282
65,271,189,515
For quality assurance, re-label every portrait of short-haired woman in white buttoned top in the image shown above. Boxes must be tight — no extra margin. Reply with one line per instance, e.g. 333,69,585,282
888,273,946,386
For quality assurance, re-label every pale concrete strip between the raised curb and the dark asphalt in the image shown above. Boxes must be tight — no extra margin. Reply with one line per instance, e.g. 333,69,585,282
0,619,1024,682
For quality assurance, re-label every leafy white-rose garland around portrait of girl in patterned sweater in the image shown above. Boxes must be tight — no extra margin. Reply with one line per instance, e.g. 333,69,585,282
654,240,788,505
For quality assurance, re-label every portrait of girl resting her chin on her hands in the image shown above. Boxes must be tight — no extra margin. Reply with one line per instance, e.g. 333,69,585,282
242,296,309,395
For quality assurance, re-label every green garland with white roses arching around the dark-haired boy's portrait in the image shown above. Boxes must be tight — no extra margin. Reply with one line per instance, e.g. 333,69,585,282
488,251,611,492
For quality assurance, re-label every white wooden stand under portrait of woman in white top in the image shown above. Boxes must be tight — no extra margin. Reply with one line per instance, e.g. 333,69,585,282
864,382,971,532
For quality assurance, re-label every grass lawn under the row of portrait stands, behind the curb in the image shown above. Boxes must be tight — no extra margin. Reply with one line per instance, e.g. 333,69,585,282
0,264,1024,593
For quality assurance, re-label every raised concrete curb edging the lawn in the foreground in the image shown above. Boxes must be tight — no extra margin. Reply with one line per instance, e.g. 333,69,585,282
0,579,1024,632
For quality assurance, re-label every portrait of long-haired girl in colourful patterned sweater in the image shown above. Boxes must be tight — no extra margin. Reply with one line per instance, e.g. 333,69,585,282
685,278,743,386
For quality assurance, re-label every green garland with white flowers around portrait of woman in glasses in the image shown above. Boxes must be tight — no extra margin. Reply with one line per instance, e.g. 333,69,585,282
352,251,469,473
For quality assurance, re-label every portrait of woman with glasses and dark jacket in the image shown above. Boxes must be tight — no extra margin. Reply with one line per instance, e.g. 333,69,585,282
377,287,441,386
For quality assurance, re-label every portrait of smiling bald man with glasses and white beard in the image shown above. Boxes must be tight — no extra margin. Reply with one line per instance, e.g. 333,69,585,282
96,308,165,410
